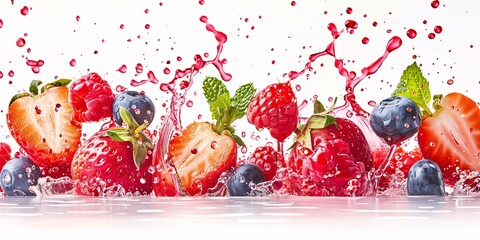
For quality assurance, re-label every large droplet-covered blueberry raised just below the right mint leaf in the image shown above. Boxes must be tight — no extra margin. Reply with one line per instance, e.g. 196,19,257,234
370,97,422,145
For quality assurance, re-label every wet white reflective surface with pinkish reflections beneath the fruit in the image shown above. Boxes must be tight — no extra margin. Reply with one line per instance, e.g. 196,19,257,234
0,195,480,239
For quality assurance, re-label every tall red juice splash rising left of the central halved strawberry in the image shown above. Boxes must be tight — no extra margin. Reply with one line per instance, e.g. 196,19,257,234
153,16,232,196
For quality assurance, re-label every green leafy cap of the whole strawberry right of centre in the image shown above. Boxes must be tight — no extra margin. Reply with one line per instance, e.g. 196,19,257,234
290,98,337,150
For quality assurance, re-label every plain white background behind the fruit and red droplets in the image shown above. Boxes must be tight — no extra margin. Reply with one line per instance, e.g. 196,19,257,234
0,0,480,158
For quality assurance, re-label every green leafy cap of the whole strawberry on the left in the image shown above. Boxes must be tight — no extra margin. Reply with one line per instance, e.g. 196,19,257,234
106,107,153,169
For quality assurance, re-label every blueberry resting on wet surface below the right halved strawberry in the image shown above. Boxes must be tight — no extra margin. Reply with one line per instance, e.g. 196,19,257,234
407,159,445,196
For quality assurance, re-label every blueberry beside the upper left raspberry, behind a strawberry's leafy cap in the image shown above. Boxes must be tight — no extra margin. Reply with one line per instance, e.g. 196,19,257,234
113,91,155,125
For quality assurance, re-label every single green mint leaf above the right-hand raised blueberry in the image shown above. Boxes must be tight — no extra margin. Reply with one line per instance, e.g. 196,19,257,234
392,62,432,115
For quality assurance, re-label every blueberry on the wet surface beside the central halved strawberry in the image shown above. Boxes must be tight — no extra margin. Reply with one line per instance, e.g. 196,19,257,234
227,163,267,196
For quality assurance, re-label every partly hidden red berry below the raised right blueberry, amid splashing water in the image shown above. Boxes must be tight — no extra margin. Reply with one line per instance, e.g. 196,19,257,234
372,146,423,192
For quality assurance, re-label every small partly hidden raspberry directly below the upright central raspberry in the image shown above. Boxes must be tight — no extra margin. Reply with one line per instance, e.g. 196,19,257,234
247,146,285,181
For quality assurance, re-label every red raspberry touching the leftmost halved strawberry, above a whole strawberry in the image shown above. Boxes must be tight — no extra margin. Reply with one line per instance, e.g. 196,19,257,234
68,73,115,123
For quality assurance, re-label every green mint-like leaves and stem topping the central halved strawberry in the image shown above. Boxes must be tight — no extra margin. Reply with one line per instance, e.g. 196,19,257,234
203,77,256,146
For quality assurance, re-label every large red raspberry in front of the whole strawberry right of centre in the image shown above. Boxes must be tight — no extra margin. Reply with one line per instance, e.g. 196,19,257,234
296,139,368,196
